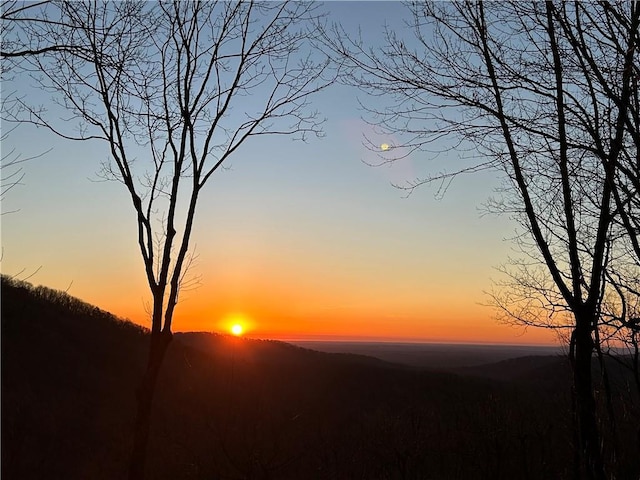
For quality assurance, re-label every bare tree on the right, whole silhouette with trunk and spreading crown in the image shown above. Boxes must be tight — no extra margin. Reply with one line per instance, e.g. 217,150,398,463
325,2,640,479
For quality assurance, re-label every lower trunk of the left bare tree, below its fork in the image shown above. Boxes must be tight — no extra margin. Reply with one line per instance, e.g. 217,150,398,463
129,331,172,480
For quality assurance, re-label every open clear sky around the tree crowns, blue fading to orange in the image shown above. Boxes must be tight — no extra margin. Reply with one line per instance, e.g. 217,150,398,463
1,2,556,344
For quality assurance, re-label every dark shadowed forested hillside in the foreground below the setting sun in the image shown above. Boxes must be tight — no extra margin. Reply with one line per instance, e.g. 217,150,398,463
2,278,638,480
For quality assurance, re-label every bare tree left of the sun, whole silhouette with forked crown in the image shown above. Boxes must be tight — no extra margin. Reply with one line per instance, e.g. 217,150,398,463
6,1,330,479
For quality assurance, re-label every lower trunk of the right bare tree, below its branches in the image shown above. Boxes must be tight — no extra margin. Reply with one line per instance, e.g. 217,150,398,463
573,318,606,480
